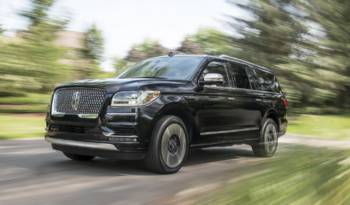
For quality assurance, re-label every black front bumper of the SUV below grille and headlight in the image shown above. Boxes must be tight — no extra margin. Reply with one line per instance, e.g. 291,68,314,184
45,103,160,159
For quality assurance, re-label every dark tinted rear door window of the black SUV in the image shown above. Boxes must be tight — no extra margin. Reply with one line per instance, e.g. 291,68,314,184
230,63,250,89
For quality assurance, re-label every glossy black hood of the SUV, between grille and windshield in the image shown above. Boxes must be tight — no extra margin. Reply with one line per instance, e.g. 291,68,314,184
56,78,191,93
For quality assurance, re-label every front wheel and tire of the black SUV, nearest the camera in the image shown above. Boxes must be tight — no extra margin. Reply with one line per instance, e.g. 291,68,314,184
145,115,189,174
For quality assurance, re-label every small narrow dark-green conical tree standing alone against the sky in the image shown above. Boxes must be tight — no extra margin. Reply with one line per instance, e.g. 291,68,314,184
83,25,104,64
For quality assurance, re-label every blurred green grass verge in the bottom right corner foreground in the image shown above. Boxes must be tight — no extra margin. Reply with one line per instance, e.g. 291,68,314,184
198,147,350,205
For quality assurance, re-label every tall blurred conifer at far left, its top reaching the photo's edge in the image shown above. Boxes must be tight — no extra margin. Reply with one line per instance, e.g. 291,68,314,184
0,0,71,95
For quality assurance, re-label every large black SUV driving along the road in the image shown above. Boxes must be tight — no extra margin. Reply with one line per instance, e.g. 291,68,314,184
45,55,288,173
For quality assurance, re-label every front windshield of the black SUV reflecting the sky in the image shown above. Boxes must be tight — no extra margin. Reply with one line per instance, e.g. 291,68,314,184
119,56,203,80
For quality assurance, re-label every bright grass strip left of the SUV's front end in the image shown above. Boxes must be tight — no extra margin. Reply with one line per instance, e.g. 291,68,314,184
0,114,45,139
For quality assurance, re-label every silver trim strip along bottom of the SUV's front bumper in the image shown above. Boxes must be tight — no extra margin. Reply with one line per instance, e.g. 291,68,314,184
45,137,118,151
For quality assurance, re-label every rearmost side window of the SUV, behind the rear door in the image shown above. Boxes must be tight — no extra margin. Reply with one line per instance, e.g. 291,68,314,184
252,69,280,92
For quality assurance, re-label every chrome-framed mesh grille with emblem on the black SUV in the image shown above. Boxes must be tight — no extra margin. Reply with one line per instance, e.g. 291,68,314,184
52,88,105,115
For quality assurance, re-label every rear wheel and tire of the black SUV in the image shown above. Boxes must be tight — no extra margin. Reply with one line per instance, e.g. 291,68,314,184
252,118,278,157
